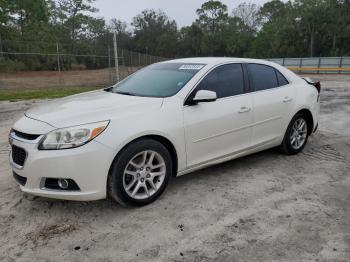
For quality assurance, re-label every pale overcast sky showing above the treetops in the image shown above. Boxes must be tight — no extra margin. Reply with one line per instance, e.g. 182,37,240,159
93,0,268,27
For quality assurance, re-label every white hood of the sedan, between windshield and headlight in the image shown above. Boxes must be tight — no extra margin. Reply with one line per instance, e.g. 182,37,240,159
25,90,163,128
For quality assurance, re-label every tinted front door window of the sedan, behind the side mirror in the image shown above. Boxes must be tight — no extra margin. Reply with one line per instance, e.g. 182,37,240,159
197,64,244,98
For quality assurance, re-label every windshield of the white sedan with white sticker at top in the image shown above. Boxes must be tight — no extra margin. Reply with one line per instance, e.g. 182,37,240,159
108,63,205,97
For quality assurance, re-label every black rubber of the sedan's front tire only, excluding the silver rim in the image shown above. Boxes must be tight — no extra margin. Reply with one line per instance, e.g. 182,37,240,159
107,139,172,206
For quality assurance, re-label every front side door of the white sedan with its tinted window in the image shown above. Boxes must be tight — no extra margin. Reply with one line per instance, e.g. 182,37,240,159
184,64,253,167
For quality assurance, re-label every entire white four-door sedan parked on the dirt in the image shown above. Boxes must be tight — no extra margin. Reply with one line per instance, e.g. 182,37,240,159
9,58,320,206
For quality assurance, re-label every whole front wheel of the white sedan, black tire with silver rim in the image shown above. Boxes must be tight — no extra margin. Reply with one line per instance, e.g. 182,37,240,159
107,139,173,206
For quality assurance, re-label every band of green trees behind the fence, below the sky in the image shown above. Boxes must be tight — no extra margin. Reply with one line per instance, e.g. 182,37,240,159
0,0,350,72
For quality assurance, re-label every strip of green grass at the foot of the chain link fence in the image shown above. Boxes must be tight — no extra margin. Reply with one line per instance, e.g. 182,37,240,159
0,87,98,101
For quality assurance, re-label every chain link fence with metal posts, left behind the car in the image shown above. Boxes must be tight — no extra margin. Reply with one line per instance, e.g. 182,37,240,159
0,37,166,90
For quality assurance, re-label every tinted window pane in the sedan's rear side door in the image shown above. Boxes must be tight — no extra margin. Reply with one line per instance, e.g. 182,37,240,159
248,64,278,91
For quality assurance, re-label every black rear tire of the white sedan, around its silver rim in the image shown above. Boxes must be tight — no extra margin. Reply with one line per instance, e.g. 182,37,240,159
280,113,312,155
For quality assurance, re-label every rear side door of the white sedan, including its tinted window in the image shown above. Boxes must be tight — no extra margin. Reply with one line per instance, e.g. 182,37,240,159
247,64,295,147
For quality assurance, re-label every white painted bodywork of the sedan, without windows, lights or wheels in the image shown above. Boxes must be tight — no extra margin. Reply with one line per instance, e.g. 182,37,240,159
10,58,319,201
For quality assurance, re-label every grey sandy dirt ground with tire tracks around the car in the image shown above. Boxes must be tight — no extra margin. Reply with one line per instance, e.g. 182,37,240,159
0,76,350,262
